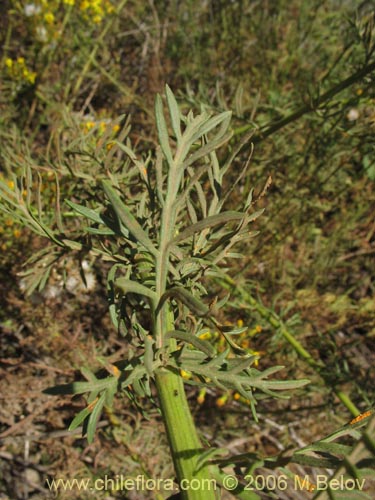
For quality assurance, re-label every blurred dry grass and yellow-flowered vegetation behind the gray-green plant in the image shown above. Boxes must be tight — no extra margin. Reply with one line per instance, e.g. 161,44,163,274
0,0,375,500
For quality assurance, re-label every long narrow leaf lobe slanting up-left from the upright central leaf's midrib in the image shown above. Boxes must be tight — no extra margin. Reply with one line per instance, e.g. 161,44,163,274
101,180,159,256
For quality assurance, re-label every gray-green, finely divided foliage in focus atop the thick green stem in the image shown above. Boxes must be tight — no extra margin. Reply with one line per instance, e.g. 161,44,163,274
3,87,307,446
